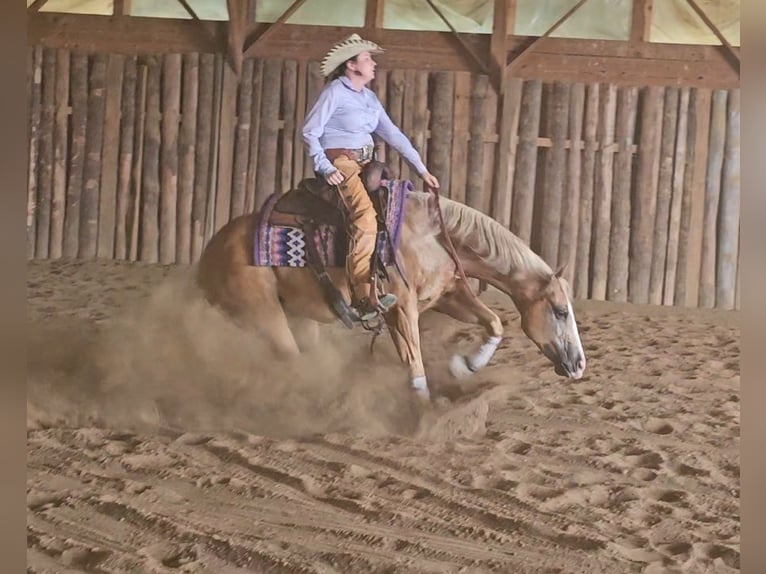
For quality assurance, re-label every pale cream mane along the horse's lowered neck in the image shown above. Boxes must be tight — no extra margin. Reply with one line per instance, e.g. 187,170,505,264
410,192,553,277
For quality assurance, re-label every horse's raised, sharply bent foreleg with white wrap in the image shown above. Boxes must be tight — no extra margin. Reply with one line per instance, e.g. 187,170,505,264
435,284,503,378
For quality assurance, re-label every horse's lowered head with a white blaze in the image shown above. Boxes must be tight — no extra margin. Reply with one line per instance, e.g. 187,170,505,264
518,268,585,379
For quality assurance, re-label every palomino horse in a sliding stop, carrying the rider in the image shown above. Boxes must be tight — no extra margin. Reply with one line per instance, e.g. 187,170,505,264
197,191,585,398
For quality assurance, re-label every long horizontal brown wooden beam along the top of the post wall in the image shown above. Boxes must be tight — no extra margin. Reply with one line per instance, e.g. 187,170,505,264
27,12,740,88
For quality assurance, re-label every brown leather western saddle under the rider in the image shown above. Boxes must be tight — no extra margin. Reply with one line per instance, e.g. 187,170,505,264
265,161,391,328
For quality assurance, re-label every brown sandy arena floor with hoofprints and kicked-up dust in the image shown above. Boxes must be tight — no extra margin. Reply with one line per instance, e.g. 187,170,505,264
27,262,740,574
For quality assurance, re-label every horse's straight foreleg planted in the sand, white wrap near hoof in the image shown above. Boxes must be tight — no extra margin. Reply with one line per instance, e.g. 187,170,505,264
386,294,431,400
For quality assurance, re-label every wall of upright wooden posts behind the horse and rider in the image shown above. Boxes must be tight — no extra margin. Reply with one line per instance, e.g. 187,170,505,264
27,48,740,309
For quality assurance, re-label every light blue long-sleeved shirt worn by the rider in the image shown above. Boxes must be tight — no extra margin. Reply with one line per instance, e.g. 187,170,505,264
303,76,427,175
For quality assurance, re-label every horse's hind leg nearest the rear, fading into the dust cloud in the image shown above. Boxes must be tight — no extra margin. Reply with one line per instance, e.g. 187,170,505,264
221,267,300,358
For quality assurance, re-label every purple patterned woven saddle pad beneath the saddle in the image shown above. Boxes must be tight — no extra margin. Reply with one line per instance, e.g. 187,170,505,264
253,180,415,267
